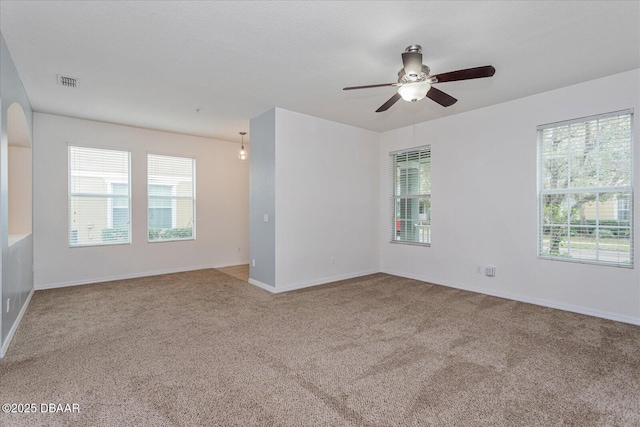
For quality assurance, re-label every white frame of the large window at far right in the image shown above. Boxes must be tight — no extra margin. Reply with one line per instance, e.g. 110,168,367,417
536,109,635,268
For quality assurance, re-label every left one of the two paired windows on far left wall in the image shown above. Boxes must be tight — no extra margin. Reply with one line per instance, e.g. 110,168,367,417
68,146,131,247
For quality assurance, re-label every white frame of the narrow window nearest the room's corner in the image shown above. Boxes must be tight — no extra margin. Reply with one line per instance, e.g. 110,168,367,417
389,145,431,247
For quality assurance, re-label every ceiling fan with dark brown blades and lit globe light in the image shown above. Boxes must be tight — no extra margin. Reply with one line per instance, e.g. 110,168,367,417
343,44,496,113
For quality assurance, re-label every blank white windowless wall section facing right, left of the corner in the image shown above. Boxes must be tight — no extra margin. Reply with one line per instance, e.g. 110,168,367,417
275,108,380,290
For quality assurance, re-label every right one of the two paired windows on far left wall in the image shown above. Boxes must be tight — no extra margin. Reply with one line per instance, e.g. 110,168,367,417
147,154,195,242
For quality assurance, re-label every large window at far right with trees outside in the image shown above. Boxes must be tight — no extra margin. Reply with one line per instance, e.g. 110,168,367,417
538,110,633,267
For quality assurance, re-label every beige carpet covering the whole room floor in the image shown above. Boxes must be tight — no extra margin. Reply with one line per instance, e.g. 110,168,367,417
0,270,640,427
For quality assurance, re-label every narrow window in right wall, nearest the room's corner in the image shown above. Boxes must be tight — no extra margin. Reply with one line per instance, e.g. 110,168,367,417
390,146,431,245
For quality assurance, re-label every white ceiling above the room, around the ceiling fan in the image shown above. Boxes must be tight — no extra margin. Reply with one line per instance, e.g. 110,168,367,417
0,0,640,145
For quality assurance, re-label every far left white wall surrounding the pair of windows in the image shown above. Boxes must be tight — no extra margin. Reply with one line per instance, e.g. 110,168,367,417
33,113,249,289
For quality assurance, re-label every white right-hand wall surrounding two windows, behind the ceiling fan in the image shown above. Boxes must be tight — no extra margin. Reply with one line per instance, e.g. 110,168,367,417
379,70,640,323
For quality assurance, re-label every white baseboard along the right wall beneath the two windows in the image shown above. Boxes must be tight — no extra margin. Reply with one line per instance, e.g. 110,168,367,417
382,269,640,326
